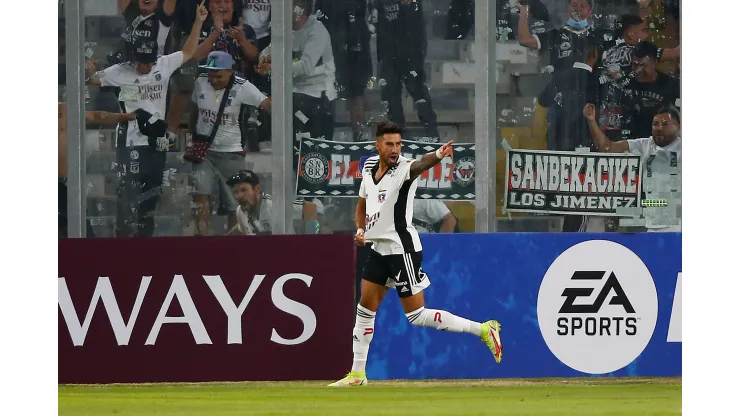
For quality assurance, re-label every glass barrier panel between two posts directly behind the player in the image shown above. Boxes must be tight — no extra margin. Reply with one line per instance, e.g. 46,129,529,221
286,0,482,233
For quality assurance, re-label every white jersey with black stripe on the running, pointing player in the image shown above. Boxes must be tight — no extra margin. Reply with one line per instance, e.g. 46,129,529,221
360,156,421,255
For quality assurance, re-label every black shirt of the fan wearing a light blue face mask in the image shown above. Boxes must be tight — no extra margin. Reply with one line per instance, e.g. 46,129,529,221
534,27,612,71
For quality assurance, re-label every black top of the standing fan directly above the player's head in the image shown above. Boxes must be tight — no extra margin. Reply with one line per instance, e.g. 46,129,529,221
373,0,427,62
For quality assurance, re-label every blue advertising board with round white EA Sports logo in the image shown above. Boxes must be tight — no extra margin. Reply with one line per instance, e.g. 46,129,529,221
358,233,681,380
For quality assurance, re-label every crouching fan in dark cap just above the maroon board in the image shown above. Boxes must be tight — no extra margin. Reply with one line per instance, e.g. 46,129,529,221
227,170,323,235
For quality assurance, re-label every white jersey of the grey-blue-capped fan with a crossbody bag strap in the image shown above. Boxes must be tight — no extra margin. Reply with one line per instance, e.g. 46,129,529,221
191,74,267,152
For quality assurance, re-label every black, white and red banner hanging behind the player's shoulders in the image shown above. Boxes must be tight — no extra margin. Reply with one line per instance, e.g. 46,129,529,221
296,138,475,201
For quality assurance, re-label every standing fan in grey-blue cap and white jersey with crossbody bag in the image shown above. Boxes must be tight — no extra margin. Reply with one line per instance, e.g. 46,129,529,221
190,51,270,235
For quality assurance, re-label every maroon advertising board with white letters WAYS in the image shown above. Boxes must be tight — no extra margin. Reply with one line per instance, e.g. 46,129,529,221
58,235,355,383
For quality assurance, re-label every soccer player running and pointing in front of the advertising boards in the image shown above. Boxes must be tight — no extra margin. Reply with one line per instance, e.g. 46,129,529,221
329,121,502,387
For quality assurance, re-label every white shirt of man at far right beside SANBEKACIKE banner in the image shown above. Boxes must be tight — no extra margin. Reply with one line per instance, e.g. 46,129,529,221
627,136,681,230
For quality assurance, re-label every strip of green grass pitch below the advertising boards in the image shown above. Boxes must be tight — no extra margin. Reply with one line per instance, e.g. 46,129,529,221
59,378,681,416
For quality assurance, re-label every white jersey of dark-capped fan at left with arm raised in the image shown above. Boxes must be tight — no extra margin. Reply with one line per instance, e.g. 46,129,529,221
99,52,183,147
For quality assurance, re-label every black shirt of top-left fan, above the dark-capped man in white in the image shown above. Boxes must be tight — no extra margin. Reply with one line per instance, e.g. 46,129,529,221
121,1,174,57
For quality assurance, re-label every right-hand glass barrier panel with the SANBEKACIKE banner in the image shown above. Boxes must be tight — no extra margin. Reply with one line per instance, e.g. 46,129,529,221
496,0,681,232
